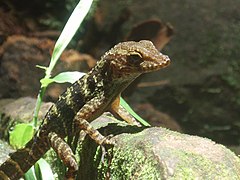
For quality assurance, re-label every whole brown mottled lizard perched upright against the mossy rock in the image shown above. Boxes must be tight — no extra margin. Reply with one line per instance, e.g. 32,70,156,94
0,40,170,180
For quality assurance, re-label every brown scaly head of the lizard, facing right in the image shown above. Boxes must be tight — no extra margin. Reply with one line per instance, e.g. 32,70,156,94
103,40,170,76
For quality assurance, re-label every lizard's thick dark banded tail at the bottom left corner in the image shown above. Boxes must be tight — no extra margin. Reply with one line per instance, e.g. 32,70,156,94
0,138,49,180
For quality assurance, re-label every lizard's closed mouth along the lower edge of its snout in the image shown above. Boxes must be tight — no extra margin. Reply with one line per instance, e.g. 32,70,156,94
140,55,170,72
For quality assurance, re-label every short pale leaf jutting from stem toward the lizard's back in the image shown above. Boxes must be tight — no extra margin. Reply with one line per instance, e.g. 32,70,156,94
52,71,85,83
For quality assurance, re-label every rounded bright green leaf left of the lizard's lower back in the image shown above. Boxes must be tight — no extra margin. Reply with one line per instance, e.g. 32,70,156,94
9,123,34,149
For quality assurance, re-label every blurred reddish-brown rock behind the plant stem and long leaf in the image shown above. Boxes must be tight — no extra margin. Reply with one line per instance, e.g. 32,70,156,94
0,35,96,100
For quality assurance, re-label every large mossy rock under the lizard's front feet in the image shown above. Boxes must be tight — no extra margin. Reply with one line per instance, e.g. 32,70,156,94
79,119,240,180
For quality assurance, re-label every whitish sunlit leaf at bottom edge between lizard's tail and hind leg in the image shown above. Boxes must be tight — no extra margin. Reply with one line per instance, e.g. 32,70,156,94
34,158,54,180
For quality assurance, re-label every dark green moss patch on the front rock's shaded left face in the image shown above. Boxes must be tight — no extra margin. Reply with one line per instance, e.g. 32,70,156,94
96,135,162,180
